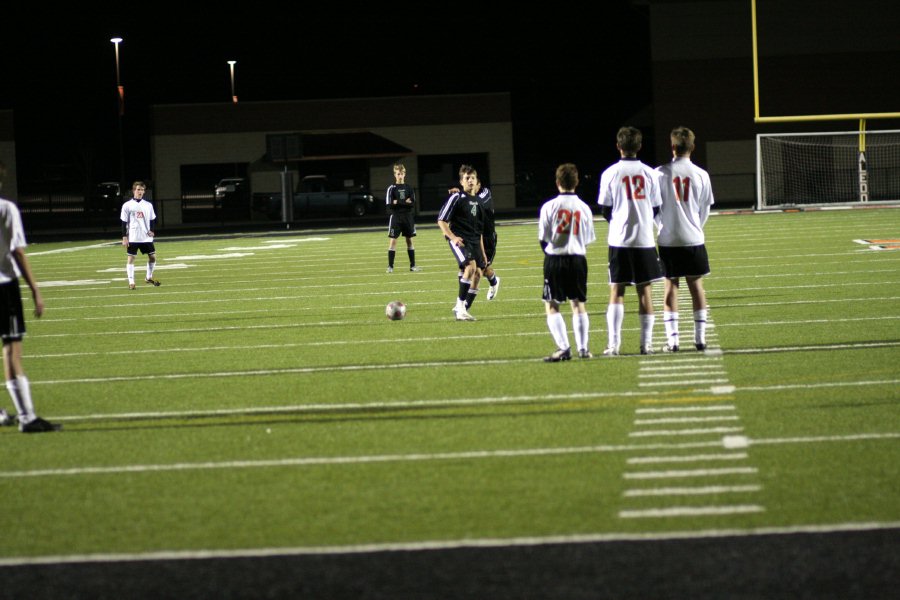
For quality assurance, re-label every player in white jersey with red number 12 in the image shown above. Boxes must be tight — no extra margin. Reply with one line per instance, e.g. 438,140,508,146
597,127,663,356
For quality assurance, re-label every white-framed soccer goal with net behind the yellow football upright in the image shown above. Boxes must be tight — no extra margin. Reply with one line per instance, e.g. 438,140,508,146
756,130,900,209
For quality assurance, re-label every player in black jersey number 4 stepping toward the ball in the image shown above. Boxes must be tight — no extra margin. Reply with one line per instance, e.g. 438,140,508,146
438,165,487,321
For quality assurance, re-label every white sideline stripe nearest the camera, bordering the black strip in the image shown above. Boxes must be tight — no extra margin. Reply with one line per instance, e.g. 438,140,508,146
0,521,900,567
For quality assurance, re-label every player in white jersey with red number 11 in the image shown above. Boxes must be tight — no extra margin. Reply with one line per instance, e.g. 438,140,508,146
657,127,715,352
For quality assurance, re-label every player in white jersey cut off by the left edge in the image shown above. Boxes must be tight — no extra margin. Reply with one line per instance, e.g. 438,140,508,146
0,163,62,433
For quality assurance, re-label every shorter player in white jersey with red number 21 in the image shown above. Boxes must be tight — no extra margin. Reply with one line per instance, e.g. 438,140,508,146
538,163,597,362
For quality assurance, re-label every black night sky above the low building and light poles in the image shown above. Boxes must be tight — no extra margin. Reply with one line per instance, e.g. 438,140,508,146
0,5,651,191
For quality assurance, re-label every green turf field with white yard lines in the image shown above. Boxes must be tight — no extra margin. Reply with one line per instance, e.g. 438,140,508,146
0,208,900,566
